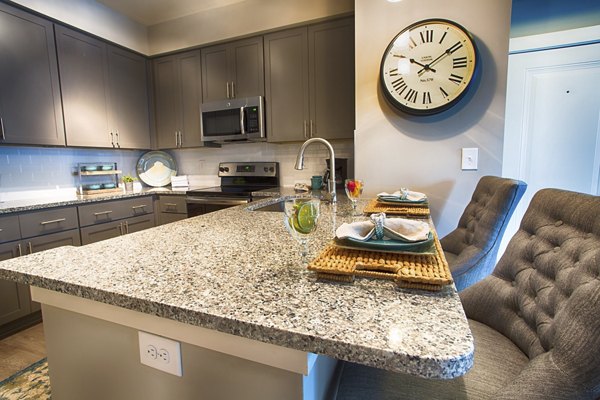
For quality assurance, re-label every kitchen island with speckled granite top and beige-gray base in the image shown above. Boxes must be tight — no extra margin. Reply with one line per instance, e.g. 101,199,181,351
0,199,473,399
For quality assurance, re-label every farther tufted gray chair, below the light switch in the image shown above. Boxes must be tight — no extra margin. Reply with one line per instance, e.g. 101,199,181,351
440,176,527,291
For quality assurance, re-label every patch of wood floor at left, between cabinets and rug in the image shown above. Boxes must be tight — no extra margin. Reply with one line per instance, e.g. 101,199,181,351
0,324,46,381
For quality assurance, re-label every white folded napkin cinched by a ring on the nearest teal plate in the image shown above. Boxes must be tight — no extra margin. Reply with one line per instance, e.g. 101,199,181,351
335,218,431,242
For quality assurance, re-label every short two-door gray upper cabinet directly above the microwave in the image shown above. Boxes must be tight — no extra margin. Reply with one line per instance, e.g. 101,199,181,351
201,37,264,103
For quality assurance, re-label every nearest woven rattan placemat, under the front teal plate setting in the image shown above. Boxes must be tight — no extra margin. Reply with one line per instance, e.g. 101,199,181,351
308,235,453,291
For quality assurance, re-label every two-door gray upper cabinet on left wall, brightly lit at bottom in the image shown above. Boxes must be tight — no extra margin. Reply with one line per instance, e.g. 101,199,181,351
56,25,150,149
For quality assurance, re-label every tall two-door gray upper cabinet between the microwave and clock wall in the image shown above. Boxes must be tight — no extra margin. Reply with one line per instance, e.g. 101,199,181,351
264,18,355,142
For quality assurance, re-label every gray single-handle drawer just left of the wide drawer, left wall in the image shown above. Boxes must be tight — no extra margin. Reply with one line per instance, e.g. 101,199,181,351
19,207,79,239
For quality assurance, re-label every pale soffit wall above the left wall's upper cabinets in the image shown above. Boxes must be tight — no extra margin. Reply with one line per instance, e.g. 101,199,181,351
13,0,148,54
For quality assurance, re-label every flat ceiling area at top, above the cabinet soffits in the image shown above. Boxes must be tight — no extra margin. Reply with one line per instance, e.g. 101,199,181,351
97,0,246,26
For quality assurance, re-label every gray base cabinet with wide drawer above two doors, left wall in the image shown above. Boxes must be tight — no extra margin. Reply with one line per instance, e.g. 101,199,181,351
78,196,155,245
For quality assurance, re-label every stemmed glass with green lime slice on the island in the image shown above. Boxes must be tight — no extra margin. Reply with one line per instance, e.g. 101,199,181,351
283,197,321,265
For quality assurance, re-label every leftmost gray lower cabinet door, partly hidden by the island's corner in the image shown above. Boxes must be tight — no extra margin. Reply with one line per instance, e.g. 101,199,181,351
0,242,31,325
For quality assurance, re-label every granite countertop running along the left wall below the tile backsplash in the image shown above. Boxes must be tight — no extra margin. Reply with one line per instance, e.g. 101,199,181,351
0,187,185,215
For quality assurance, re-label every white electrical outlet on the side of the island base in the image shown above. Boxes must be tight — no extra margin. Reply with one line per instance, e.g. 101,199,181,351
138,331,182,376
